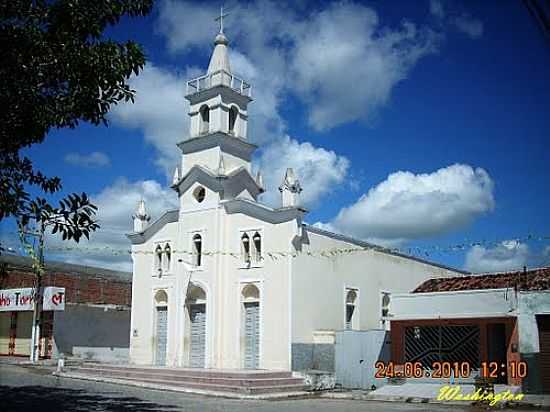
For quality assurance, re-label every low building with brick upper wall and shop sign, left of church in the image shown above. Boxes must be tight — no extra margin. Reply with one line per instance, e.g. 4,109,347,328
0,256,132,362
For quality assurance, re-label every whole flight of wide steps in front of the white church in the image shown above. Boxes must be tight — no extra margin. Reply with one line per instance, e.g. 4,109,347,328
57,364,314,399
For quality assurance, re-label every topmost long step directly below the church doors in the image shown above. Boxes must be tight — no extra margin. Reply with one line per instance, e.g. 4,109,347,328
75,363,298,379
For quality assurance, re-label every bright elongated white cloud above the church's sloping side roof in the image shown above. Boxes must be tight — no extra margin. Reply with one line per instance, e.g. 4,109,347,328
330,164,494,240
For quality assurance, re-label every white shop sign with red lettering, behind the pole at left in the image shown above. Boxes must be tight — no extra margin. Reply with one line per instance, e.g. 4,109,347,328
0,286,65,312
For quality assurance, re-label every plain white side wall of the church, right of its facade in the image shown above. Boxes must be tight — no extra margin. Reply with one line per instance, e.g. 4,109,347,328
291,232,459,343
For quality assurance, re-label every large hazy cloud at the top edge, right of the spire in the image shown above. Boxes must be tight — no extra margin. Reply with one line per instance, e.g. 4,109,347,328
291,3,439,130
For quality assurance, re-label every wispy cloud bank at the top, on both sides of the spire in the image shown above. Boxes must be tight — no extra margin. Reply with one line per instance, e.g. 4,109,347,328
158,0,440,132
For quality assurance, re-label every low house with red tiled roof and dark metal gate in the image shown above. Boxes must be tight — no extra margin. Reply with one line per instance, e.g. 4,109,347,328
387,267,550,393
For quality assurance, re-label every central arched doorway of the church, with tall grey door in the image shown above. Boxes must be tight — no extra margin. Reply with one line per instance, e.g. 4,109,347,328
186,283,206,368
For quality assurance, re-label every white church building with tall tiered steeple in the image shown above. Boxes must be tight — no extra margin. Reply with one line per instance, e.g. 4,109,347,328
128,31,459,370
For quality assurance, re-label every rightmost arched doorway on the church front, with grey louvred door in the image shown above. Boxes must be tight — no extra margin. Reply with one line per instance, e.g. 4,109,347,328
241,284,260,369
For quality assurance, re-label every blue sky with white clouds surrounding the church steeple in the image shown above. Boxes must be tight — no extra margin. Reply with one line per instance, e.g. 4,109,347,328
0,0,550,271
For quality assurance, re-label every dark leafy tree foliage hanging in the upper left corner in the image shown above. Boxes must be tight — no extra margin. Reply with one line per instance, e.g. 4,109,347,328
0,0,152,246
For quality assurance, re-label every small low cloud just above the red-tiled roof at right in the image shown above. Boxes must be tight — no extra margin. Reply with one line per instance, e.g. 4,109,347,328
464,240,529,272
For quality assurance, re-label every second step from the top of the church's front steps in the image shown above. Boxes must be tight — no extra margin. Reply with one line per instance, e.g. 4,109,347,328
67,367,303,387
